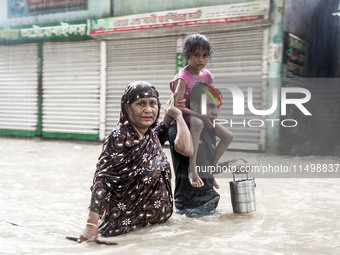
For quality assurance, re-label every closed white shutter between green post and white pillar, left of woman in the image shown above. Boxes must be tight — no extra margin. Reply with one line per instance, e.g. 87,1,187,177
42,41,100,139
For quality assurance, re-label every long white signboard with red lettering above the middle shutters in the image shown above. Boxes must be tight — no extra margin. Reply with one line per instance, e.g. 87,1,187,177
88,0,269,35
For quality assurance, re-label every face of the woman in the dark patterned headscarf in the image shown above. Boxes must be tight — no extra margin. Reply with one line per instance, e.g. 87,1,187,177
125,97,158,136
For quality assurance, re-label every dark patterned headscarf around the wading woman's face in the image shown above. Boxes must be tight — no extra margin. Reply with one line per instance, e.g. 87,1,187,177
119,81,161,128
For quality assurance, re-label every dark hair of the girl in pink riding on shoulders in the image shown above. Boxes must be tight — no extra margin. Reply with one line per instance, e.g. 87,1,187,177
182,34,213,65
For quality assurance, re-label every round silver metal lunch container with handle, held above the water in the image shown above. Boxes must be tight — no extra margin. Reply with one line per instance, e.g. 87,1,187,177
229,173,256,213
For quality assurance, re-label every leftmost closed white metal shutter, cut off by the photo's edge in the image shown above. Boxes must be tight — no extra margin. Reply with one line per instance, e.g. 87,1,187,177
0,44,38,136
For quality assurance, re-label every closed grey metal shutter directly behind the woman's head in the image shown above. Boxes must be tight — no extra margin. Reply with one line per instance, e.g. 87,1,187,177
106,37,176,135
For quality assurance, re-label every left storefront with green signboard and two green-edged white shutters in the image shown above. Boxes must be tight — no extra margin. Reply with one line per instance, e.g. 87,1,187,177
0,21,100,140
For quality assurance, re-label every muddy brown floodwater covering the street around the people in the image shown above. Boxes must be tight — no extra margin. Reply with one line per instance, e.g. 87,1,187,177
0,137,340,255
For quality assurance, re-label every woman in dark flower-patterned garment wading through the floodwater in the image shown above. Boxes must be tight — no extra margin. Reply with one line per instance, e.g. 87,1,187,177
79,82,190,242
